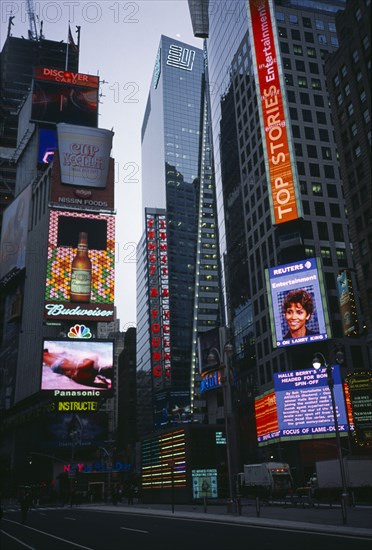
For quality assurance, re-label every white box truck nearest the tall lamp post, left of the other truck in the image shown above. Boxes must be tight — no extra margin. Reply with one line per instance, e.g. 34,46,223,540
237,462,293,497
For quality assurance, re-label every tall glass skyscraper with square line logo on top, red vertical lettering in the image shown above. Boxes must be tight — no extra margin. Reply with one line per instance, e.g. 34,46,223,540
137,36,221,432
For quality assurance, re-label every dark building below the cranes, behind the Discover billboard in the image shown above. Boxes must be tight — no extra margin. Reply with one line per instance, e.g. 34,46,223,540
0,25,79,216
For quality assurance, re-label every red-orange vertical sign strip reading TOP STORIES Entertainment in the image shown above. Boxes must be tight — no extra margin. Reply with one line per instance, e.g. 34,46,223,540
248,0,301,224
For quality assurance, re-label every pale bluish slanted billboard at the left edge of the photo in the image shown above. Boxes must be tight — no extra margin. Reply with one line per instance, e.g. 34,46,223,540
0,185,32,279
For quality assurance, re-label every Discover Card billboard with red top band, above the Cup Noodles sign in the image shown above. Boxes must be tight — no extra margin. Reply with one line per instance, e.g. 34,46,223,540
31,67,99,127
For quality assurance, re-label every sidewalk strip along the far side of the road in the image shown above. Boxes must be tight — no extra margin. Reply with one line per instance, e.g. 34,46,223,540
79,501,372,539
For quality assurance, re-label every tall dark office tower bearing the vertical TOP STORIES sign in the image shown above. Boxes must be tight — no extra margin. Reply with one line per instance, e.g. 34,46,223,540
190,0,368,470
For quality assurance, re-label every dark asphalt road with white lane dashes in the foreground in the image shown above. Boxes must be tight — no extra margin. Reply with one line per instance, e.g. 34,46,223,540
0,508,371,550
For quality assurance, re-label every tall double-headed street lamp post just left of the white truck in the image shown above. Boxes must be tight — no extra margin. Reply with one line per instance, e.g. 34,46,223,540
207,342,234,513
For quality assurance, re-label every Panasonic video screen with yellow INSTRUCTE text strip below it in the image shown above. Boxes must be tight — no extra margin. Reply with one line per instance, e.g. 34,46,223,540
41,339,114,396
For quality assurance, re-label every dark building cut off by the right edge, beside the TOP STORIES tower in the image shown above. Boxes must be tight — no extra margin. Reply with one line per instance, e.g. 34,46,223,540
326,0,372,354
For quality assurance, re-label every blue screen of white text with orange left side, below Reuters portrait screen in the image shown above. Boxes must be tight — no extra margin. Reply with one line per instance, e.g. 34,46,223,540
255,365,354,444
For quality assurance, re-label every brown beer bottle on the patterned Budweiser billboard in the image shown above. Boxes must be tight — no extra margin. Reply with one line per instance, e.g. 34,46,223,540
70,233,92,302
